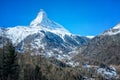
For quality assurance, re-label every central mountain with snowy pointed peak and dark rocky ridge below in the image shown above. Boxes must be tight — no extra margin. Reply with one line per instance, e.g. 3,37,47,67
0,10,89,58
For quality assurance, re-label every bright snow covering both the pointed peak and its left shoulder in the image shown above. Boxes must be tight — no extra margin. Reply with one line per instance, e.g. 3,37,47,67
6,10,71,44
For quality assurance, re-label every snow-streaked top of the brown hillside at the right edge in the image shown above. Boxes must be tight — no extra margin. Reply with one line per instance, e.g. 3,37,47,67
102,23,120,35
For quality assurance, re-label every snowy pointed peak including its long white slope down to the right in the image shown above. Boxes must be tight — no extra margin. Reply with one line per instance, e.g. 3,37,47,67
30,10,71,36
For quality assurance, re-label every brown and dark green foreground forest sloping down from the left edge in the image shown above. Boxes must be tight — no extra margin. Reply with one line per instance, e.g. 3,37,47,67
0,42,81,80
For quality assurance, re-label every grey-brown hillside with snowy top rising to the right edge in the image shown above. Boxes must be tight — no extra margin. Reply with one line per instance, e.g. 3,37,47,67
76,24,120,64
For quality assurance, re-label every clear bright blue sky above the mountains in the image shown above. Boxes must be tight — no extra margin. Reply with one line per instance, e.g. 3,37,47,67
0,0,120,36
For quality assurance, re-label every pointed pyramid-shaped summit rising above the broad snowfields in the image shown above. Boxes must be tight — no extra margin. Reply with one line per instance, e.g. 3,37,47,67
30,9,68,29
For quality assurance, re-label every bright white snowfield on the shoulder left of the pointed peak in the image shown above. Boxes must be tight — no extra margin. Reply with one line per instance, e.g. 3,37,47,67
6,26,39,45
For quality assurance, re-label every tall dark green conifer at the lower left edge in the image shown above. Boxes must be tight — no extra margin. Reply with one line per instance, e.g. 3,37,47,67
1,42,19,80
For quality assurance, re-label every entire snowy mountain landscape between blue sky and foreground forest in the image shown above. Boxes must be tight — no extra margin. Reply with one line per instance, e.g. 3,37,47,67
0,10,120,79
